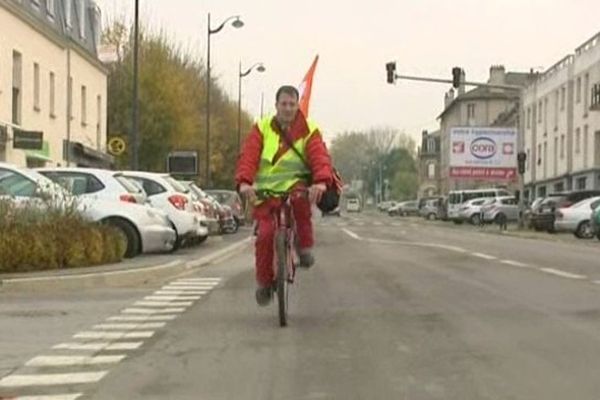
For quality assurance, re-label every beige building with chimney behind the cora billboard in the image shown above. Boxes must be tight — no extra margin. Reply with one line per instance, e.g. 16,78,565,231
439,66,533,194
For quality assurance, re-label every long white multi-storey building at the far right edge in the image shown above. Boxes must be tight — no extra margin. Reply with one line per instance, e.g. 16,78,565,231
522,33,600,198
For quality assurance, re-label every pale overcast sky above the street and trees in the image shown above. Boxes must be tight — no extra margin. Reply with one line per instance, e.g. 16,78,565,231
96,0,600,143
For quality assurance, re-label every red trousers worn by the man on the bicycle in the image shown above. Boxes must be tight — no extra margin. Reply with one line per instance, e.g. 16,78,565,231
254,194,314,287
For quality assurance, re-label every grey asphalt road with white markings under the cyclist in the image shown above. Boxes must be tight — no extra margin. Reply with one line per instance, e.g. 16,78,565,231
0,214,600,400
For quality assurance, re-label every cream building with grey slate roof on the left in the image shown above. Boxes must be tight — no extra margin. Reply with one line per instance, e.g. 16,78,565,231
0,0,112,167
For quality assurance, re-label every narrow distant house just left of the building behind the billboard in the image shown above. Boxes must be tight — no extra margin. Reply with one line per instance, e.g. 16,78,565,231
418,130,441,198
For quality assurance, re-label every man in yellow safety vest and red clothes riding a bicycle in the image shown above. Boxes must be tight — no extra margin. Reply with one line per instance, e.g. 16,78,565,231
235,86,333,306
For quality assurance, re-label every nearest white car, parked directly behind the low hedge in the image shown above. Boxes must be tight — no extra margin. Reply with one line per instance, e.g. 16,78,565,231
0,163,176,258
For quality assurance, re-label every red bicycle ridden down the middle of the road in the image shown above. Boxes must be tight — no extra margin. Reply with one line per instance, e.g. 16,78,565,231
257,190,306,327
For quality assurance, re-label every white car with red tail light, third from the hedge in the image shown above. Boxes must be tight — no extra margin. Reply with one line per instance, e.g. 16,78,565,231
123,171,208,248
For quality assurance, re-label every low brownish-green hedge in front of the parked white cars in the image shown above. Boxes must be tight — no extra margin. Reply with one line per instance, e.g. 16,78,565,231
0,200,126,272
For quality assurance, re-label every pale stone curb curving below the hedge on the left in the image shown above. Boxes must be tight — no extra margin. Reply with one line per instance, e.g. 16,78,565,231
0,237,252,291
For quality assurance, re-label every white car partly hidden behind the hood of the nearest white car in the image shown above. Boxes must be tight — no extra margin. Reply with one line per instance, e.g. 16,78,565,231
36,168,148,204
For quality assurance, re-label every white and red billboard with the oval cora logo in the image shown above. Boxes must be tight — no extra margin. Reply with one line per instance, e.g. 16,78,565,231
450,127,517,181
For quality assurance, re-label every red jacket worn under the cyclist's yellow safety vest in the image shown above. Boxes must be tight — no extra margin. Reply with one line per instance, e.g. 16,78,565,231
235,111,333,186
